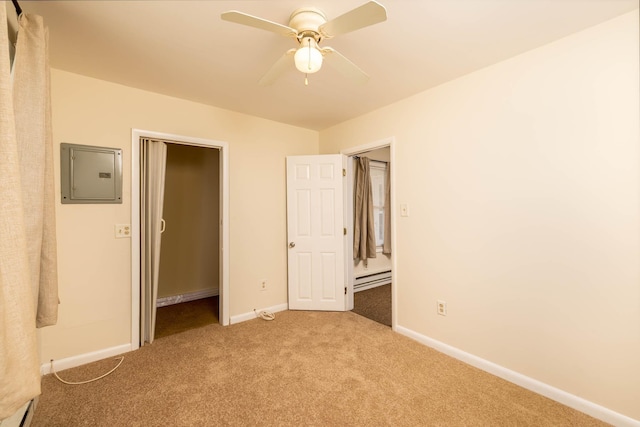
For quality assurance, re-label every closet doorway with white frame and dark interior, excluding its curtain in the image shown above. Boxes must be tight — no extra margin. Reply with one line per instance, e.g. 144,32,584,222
131,130,229,349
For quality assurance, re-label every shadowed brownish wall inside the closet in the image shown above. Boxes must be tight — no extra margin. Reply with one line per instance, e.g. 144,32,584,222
158,144,220,298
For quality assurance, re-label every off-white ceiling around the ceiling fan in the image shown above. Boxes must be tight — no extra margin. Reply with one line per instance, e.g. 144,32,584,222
20,0,638,130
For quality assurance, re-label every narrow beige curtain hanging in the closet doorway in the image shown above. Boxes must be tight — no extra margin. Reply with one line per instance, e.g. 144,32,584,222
140,139,167,344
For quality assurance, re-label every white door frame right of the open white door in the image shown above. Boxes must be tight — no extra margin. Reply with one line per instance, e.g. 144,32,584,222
340,137,398,331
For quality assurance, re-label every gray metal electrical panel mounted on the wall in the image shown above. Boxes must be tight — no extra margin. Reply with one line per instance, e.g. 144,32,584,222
60,142,122,204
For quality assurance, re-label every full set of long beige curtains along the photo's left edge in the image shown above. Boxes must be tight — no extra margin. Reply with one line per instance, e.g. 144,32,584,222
0,6,58,419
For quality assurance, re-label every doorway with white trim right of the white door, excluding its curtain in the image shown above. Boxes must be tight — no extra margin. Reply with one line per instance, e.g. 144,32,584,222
342,138,396,328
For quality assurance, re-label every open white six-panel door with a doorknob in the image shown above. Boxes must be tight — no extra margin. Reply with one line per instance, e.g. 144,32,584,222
287,154,346,311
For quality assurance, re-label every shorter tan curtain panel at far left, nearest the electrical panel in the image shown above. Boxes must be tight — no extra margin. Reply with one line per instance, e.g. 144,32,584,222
13,14,58,327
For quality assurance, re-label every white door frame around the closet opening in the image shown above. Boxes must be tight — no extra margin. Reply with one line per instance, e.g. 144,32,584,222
131,129,230,350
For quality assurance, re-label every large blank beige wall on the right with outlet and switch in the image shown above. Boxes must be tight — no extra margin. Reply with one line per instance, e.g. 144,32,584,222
320,10,640,419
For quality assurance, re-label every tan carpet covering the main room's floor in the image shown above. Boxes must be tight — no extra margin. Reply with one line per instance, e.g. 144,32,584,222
32,311,603,427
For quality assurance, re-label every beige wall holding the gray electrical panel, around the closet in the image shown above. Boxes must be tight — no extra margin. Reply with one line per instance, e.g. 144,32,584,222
40,69,318,362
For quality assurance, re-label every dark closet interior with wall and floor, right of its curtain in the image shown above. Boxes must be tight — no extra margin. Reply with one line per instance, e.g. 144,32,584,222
155,142,220,339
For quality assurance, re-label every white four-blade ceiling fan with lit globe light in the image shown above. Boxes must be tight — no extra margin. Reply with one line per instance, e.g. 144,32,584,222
221,1,387,86
